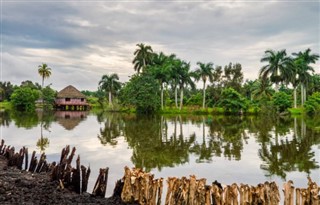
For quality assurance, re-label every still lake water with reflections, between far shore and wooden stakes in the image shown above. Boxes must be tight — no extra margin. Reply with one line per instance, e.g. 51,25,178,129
0,111,320,196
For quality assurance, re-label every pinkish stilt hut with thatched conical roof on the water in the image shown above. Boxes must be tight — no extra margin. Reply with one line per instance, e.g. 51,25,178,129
55,85,89,111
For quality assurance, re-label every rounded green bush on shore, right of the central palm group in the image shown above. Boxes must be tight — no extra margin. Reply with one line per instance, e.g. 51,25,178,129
219,88,248,113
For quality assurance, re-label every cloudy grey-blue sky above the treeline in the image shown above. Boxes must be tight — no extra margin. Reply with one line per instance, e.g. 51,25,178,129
0,0,320,90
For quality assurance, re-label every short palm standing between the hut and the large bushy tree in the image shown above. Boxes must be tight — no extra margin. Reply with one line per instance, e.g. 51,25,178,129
99,73,121,106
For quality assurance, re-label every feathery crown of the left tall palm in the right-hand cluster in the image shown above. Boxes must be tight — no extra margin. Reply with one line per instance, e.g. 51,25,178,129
259,50,292,92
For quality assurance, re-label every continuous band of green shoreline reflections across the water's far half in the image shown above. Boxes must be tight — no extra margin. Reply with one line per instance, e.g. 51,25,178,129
0,111,320,180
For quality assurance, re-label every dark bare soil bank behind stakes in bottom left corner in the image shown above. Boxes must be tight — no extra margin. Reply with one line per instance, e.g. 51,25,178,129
0,155,138,205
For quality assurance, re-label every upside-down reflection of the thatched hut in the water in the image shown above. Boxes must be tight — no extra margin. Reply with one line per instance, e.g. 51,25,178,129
54,111,88,130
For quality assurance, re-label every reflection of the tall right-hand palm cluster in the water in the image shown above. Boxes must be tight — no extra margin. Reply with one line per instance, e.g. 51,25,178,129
259,117,319,179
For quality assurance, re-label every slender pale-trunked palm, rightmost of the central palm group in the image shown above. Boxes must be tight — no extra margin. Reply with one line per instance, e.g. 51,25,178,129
195,62,214,108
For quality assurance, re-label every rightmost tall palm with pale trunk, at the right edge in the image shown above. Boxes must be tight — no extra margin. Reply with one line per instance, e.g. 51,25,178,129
292,48,319,105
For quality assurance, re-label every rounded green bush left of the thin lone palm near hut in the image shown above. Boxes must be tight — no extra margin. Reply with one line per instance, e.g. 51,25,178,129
11,87,39,111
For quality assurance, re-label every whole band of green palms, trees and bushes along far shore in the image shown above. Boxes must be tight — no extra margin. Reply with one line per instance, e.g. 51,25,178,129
0,43,320,114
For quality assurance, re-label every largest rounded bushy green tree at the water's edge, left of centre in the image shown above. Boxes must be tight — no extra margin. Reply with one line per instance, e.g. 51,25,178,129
119,73,160,114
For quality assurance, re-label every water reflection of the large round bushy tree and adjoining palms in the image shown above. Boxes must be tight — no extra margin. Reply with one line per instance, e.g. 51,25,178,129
124,116,195,171
